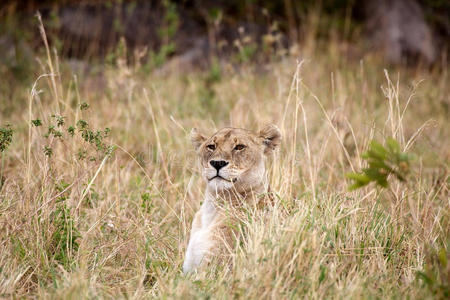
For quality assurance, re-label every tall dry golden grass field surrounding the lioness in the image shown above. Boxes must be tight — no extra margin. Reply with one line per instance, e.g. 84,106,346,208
0,25,450,299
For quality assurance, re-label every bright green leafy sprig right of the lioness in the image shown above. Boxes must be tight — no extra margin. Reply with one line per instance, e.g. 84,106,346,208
347,138,411,190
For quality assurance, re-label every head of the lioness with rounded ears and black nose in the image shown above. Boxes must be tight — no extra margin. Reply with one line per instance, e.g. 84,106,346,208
191,125,281,193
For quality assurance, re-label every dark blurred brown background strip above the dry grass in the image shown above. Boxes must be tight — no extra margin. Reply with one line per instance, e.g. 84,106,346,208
0,0,450,67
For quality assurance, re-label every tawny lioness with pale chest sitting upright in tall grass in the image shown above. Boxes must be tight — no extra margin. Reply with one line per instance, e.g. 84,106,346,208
183,125,281,273
